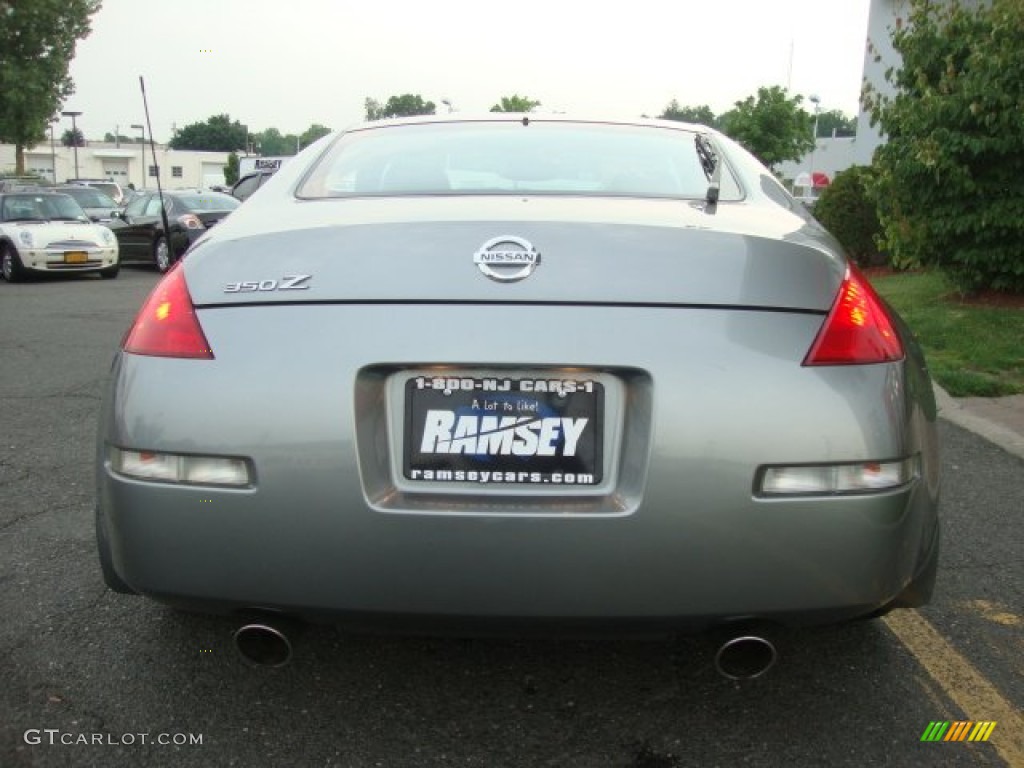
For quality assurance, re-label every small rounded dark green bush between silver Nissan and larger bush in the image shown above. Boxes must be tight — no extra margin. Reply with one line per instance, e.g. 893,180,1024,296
814,166,888,266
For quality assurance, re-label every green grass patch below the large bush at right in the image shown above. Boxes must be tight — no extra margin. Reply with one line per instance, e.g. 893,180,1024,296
871,271,1024,397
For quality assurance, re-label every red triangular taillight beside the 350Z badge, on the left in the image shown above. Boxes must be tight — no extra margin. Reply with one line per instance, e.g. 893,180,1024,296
122,261,213,359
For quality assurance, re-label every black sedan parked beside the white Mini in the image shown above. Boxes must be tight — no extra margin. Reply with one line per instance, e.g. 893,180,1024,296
111,189,240,272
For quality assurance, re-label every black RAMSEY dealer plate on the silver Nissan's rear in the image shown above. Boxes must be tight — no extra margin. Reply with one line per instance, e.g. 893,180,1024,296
402,375,604,487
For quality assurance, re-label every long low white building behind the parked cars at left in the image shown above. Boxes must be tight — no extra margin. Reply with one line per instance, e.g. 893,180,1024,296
0,141,228,189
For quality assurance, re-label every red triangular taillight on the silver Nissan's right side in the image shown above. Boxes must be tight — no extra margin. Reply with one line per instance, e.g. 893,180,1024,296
804,266,903,366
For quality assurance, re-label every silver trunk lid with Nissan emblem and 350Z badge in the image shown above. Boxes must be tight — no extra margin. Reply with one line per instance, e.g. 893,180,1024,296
185,198,845,312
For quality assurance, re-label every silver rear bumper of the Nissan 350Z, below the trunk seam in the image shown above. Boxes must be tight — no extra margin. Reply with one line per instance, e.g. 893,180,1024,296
98,307,938,629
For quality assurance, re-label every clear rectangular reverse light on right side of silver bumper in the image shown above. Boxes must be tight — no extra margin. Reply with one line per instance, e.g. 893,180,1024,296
758,459,916,496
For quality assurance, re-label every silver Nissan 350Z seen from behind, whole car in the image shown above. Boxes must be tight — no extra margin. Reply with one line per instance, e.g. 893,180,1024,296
96,115,939,671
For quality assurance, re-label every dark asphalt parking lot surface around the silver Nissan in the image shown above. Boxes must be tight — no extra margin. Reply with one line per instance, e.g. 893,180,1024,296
0,267,1024,768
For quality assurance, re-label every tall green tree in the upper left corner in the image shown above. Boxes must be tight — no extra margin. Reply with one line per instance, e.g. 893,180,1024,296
0,0,99,174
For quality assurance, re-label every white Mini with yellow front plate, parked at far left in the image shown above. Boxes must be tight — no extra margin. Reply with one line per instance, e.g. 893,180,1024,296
0,190,119,283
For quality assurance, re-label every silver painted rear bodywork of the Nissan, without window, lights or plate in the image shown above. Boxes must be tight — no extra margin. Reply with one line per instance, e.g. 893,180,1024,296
97,115,938,627
